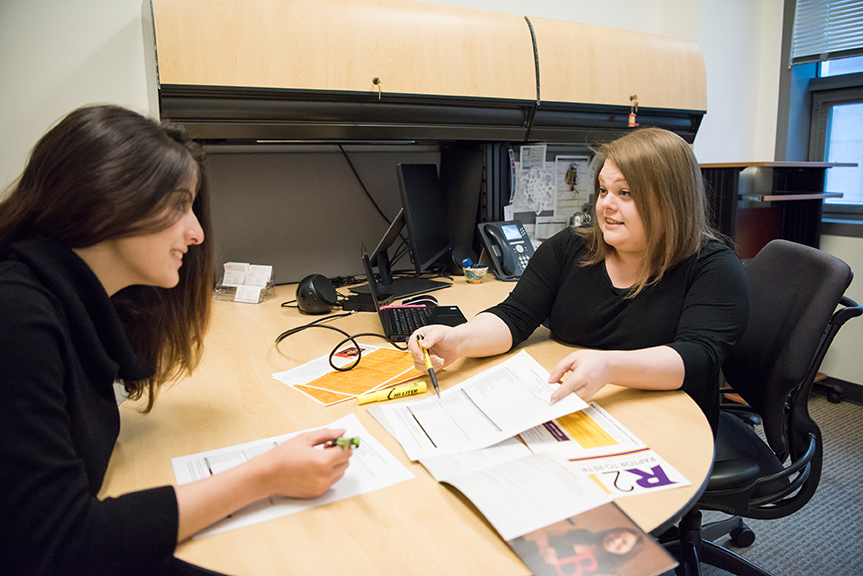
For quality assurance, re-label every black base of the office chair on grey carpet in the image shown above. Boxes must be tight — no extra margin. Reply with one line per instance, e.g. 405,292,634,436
660,510,772,576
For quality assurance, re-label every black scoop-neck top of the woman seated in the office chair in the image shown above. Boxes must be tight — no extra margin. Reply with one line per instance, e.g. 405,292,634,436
488,228,749,433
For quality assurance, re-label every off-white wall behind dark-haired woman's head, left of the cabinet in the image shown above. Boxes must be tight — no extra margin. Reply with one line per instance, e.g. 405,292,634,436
0,0,149,190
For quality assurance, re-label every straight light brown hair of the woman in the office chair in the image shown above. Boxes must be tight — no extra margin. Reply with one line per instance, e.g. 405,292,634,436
578,128,719,298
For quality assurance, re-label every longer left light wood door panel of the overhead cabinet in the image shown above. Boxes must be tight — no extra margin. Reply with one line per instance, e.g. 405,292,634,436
153,0,536,100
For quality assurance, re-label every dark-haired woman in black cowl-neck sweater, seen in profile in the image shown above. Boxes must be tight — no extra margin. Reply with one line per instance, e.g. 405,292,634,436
0,106,350,575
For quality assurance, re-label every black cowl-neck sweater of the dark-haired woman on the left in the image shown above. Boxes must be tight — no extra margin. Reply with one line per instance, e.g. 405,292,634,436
0,238,177,575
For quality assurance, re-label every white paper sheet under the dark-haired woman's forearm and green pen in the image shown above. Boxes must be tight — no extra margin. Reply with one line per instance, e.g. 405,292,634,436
171,414,415,538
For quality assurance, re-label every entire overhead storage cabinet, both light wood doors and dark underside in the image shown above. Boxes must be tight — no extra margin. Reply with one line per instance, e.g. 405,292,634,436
145,0,706,142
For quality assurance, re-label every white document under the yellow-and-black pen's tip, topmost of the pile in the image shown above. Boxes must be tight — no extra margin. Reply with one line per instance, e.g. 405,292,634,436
381,350,587,460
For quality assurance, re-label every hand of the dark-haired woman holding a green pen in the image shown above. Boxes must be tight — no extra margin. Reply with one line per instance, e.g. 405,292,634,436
262,429,353,498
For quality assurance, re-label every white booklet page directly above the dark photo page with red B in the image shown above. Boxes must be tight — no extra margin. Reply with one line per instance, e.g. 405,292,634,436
443,454,611,540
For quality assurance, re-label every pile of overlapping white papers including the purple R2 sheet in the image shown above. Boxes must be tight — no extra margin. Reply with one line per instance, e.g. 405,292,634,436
369,351,689,541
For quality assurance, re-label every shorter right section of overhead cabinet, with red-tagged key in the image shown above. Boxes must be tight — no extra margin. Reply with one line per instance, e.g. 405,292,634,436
528,17,707,142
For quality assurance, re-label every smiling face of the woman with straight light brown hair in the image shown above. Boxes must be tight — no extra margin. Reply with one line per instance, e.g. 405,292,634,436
596,160,647,255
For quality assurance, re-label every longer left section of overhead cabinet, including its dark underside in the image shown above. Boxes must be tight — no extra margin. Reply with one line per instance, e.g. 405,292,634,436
152,0,536,140
